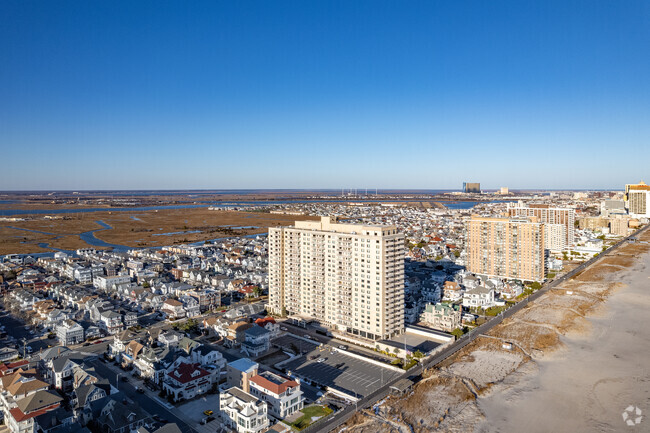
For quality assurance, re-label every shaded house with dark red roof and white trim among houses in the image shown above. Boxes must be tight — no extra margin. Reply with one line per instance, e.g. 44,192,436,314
163,362,215,401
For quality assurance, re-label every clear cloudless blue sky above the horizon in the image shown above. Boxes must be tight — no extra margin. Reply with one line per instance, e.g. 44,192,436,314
0,0,650,190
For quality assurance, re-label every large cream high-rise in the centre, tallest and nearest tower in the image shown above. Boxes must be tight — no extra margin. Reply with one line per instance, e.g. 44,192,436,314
269,217,404,340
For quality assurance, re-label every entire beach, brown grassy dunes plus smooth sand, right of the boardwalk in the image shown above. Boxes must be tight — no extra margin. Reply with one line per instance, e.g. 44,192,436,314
339,228,650,433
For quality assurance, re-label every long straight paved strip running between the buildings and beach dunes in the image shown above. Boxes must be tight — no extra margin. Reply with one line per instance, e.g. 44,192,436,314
303,225,650,433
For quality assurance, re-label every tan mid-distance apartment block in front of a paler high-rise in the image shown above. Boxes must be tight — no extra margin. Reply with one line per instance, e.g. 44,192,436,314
467,215,546,281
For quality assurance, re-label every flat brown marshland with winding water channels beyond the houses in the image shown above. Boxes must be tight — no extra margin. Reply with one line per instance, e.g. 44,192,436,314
0,208,316,254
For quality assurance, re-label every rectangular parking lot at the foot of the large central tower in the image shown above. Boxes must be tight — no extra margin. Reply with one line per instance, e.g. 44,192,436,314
282,346,401,397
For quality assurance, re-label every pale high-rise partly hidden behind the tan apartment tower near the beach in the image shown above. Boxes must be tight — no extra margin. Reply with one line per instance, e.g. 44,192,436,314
508,201,576,251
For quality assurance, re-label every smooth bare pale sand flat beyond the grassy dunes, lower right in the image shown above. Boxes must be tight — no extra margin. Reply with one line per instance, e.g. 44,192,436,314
475,246,650,432
